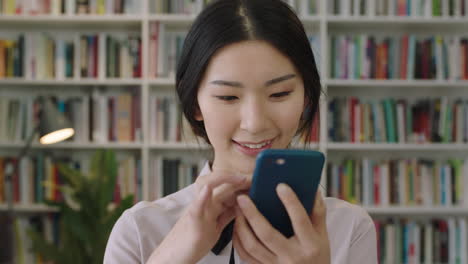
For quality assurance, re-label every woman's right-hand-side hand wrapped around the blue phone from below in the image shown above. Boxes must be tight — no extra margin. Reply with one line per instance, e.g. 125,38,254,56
233,184,330,264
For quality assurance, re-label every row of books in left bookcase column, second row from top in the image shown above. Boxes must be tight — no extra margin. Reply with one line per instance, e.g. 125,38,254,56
0,32,142,80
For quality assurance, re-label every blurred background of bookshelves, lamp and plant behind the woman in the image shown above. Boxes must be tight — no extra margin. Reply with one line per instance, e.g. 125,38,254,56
0,0,468,264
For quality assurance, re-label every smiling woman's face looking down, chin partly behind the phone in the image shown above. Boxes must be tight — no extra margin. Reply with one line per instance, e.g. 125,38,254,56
196,41,305,175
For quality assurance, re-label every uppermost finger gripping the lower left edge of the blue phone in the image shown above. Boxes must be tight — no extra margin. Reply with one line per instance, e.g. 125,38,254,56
237,195,288,255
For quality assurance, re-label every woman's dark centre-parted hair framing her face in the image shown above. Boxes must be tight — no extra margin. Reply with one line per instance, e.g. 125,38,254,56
176,0,321,143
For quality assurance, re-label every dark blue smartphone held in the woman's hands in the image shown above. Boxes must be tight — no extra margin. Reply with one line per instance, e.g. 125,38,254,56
249,149,325,238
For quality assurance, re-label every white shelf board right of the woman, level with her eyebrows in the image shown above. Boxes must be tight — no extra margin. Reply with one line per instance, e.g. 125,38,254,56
324,79,468,88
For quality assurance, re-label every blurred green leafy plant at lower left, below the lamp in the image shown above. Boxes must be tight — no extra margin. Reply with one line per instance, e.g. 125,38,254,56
28,150,133,264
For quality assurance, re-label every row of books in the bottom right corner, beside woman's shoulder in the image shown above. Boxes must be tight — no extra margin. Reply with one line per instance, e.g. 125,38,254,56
374,217,468,264
